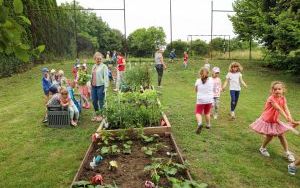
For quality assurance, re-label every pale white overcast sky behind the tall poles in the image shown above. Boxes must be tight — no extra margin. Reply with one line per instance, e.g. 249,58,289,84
57,0,234,42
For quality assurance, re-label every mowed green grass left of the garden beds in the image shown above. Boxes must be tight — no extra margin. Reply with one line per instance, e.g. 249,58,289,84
0,63,98,188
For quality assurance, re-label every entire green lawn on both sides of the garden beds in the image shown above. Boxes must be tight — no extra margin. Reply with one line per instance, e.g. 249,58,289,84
0,60,300,187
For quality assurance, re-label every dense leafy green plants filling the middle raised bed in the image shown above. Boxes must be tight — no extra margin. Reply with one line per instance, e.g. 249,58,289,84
104,90,162,129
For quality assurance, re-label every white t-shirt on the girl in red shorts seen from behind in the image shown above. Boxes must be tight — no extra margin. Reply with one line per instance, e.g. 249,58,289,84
195,77,214,104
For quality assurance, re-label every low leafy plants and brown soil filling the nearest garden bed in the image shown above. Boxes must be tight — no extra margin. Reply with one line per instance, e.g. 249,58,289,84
72,130,207,188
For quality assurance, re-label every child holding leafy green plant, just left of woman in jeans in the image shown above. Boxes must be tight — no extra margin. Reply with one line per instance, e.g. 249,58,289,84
78,63,90,109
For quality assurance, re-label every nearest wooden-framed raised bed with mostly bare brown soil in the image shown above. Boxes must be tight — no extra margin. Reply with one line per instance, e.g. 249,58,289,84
71,129,192,188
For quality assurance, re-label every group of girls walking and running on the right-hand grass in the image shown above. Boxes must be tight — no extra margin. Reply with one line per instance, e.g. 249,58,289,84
195,60,300,175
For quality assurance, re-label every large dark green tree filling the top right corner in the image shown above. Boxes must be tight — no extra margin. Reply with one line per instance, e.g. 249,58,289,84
230,0,300,72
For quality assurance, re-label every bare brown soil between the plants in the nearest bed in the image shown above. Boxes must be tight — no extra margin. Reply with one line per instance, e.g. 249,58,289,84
77,137,187,188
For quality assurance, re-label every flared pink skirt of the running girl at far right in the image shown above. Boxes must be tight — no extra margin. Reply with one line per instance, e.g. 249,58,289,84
250,117,289,136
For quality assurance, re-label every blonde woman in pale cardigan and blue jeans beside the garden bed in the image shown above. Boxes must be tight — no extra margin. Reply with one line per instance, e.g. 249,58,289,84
91,52,109,121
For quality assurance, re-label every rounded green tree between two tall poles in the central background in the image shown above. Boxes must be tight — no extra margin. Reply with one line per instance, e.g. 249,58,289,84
128,27,166,57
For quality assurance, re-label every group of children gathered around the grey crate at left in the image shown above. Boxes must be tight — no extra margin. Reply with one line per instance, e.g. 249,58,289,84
42,59,91,126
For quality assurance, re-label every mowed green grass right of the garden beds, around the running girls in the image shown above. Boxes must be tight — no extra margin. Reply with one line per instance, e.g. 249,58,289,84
161,60,300,187
